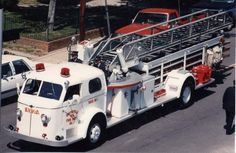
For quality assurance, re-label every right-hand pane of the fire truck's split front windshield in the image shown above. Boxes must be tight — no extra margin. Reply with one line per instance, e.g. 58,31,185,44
39,81,62,100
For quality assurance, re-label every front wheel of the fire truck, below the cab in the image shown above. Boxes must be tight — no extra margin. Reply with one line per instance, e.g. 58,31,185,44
86,117,105,148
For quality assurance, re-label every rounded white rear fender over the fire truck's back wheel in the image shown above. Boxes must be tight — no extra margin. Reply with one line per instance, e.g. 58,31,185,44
165,70,196,98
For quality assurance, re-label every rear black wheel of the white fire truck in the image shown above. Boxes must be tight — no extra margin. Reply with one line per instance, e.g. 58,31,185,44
179,79,194,109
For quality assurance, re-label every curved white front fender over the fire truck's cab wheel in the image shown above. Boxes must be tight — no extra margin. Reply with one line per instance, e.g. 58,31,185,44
78,108,105,139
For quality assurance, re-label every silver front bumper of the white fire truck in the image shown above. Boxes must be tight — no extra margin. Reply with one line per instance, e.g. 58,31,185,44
4,127,70,147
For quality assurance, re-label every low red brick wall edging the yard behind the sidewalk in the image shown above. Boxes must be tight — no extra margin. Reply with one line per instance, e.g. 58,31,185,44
17,28,104,53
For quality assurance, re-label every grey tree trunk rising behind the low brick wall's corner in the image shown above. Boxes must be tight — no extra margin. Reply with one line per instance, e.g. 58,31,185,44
47,0,56,31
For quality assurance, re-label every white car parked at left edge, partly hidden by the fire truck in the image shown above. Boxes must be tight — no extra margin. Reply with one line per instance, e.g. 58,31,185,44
1,55,34,99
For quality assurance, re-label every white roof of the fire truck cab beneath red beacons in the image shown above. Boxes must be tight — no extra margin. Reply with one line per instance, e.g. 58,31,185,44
28,62,104,85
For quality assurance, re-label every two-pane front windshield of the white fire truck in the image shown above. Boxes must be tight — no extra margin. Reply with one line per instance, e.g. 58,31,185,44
23,79,63,100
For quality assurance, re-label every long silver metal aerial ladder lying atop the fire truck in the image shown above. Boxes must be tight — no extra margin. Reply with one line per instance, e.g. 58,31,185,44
68,9,232,86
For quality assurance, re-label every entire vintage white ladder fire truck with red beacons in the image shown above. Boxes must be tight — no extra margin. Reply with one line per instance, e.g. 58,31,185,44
6,10,232,147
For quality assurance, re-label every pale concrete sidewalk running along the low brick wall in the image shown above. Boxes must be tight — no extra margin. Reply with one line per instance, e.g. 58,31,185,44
4,37,102,64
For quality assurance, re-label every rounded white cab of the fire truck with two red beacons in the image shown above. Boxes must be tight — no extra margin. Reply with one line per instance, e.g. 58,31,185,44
9,63,107,146
